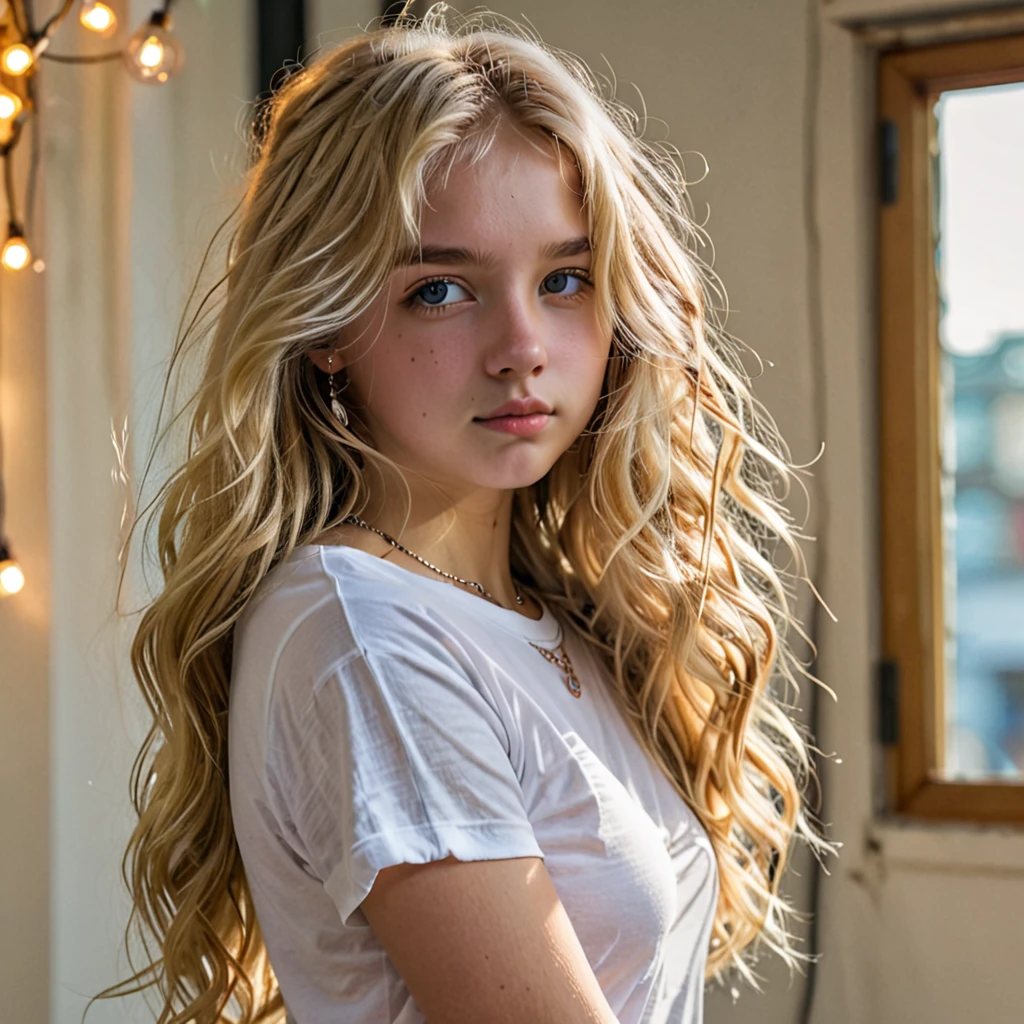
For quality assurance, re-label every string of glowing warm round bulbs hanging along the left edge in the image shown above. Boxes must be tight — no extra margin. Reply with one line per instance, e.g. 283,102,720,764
0,0,184,598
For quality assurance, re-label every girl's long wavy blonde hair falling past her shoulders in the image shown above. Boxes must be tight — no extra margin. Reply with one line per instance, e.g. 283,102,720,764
90,4,835,1024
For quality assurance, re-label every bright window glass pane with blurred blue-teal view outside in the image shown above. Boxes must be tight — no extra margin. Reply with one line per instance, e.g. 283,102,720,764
933,83,1024,780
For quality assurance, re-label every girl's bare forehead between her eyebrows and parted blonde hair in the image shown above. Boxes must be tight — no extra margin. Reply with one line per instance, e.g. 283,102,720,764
420,119,587,248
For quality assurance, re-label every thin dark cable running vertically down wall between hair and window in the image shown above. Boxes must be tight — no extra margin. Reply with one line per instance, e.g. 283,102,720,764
799,0,829,1024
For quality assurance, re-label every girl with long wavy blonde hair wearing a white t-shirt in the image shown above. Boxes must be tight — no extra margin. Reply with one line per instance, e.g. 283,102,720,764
92,5,830,1024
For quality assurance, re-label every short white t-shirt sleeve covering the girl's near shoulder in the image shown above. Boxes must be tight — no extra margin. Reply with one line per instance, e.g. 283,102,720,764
267,622,544,926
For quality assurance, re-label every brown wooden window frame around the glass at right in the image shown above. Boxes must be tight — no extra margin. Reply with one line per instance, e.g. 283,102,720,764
878,34,1024,824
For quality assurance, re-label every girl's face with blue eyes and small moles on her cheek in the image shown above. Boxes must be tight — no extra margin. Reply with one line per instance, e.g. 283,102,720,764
311,119,610,507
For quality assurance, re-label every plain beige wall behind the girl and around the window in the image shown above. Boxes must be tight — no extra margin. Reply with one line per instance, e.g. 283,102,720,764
0,0,1024,1024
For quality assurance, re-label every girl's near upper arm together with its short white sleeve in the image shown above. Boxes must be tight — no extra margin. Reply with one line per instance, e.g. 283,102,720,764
268,609,615,1024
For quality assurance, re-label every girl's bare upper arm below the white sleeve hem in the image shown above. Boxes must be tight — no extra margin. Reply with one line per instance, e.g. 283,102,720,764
360,856,616,1024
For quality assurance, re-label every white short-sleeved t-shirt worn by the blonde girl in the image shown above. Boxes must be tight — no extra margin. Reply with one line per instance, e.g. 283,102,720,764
228,545,718,1024
